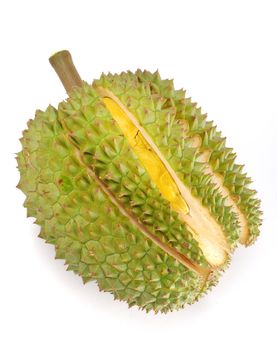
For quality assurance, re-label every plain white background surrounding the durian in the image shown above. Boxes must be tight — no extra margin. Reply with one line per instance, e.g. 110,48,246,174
0,0,277,350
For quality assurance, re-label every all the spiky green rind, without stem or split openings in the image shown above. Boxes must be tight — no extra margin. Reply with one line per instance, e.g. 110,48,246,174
17,71,260,312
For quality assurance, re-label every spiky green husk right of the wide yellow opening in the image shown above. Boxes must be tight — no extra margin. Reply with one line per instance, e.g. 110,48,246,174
95,70,262,247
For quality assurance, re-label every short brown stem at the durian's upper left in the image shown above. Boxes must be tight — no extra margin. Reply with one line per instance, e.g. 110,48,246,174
49,50,82,94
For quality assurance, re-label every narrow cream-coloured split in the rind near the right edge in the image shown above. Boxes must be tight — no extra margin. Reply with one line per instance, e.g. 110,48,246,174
200,151,249,244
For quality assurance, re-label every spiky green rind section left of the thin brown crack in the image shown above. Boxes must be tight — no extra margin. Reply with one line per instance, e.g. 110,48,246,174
17,87,216,312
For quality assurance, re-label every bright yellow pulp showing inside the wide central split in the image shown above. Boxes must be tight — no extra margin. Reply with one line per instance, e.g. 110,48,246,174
103,97,189,215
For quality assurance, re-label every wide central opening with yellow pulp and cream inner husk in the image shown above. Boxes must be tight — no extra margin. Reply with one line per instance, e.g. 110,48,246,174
97,87,229,266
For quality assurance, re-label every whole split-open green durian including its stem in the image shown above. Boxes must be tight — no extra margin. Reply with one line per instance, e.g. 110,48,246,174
17,51,261,312
